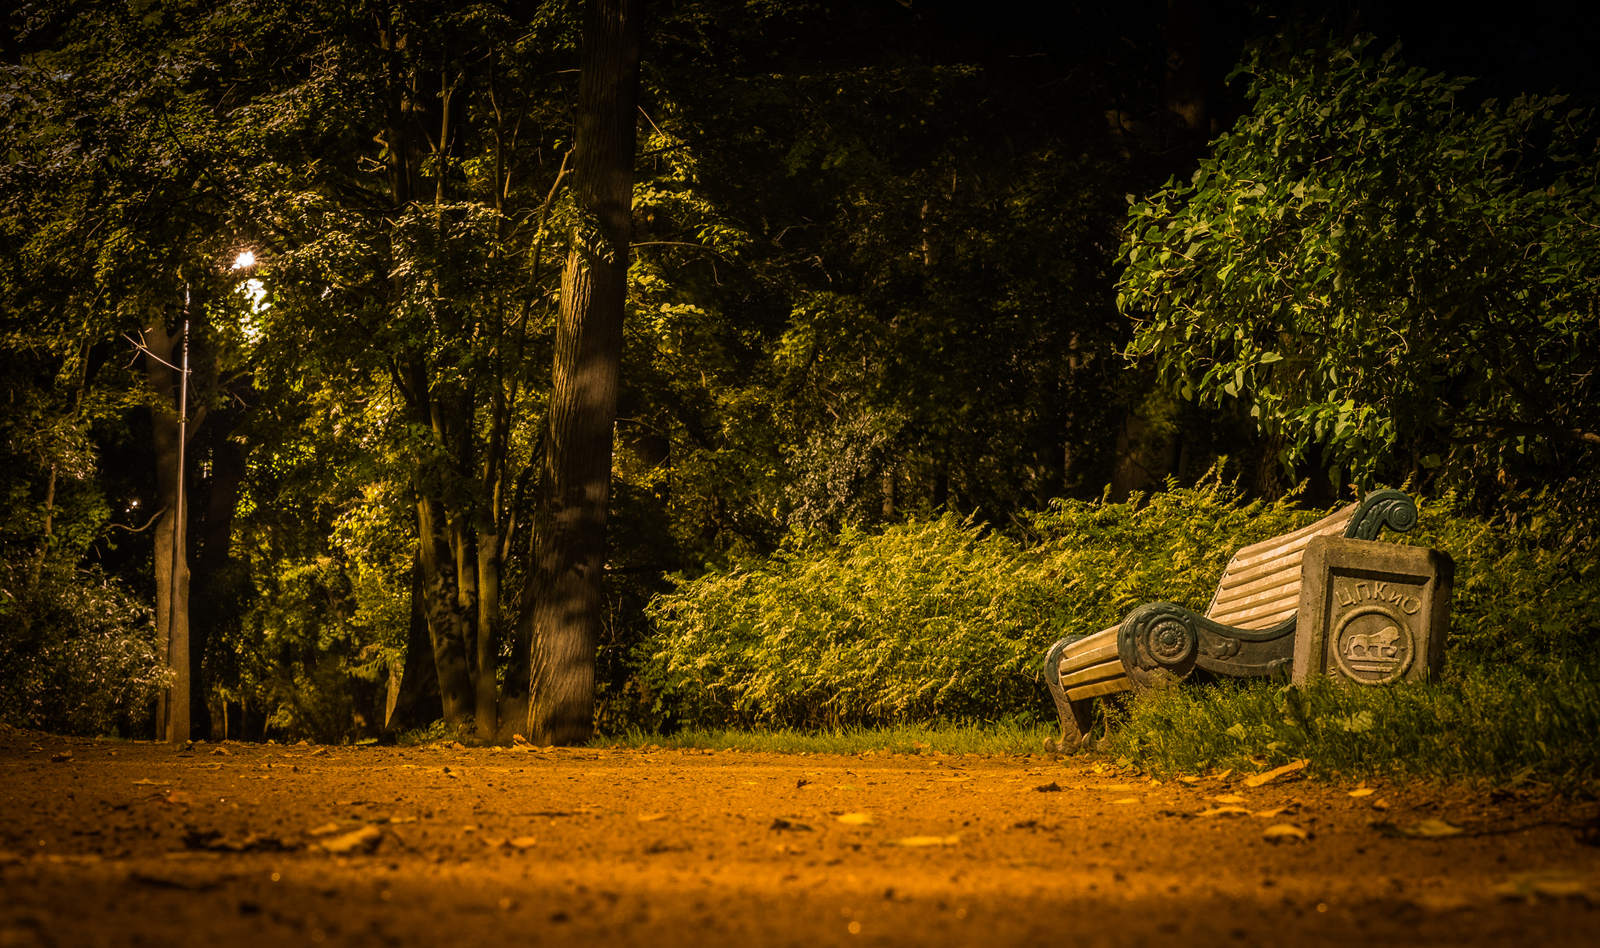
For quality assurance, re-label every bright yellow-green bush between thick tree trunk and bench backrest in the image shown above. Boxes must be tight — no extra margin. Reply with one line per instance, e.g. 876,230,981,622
638,482,1315,727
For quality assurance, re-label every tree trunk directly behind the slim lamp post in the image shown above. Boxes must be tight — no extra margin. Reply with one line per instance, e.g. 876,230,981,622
144,323,192,741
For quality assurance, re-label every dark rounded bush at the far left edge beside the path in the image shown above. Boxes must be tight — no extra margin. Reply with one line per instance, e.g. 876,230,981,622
0,564,171,735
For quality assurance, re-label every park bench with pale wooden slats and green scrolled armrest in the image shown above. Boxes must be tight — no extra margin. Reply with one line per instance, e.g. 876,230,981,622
1045,490,1416,749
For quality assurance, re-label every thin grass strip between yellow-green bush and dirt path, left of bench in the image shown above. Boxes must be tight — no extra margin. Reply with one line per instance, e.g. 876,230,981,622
594,721,1054,756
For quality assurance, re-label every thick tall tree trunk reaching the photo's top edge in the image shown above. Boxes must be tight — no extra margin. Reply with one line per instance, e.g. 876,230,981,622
528,0,640,745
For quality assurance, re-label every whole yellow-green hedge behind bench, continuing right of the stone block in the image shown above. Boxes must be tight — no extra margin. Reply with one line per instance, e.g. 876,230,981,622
637,479,1600,729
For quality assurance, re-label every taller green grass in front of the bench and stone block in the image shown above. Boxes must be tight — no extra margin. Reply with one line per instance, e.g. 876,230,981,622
1106,668,1600,789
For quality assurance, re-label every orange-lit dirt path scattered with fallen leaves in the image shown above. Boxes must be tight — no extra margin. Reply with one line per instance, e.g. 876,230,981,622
0,732,1600,948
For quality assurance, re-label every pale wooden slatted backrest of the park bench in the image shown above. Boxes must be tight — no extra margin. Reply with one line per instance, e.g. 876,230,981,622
1205,504,1362,629
